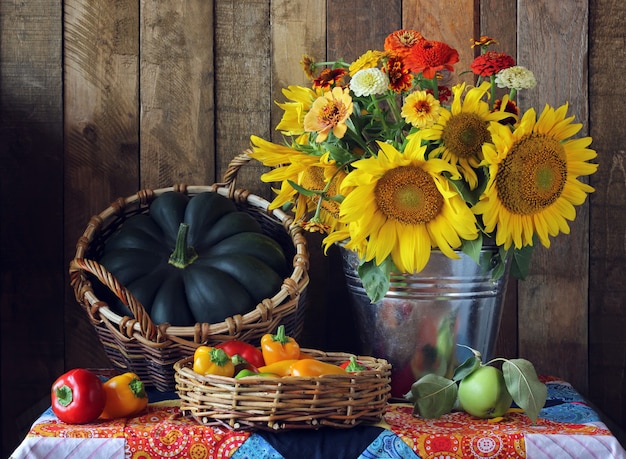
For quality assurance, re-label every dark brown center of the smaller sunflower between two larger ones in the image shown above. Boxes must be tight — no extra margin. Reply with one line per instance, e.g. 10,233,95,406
441,113,491,158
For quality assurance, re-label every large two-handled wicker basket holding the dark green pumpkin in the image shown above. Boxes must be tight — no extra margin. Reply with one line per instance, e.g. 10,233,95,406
70,153,309,392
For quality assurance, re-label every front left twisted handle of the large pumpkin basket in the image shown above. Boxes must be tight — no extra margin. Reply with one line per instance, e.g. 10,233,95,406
70,258,166,342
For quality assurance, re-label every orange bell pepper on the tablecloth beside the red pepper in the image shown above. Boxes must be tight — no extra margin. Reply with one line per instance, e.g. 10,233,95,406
100,372,148,419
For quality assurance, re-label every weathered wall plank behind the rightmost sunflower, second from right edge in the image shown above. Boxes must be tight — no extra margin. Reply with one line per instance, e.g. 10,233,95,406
518,0,589,393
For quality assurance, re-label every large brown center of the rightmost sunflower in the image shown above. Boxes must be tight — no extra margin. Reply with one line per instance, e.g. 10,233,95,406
496,135,567,215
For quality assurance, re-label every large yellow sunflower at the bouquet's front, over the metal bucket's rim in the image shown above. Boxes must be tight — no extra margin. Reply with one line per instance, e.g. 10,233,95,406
340,136,478,273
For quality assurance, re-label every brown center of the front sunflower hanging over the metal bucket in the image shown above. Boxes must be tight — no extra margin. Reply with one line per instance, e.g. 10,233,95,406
374,166,443,225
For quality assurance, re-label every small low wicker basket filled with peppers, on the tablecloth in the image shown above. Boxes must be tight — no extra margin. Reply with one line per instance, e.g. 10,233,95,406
174,349,391,431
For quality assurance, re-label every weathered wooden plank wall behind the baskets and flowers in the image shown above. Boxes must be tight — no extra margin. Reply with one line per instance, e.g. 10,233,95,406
0,0,626,456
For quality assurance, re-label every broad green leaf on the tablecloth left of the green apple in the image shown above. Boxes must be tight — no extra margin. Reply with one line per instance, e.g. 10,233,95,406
405,373,458,419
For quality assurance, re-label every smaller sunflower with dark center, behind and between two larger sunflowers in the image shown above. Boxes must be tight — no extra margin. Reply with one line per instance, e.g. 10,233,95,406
421,82,511,190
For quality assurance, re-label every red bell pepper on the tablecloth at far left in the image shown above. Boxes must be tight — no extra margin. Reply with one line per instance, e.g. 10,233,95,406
51,368,106,424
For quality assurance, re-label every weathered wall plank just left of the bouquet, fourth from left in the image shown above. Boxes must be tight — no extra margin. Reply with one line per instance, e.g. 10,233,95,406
215,0,273,197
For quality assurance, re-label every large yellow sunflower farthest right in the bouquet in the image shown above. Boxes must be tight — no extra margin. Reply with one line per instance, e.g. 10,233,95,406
473,104,598,249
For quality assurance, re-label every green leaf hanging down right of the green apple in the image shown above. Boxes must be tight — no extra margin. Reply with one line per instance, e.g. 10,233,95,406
502,359,548,423
